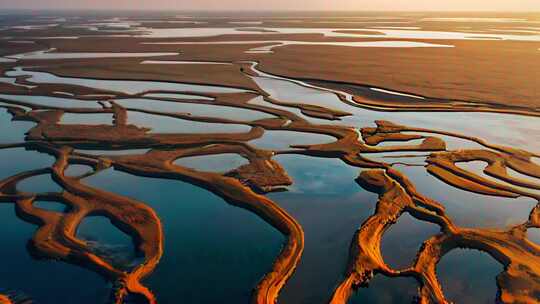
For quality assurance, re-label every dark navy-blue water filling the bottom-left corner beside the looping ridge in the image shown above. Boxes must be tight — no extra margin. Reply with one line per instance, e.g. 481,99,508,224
0,203,110,304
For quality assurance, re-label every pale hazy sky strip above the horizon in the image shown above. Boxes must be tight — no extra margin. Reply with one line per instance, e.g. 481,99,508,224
0,0,540,11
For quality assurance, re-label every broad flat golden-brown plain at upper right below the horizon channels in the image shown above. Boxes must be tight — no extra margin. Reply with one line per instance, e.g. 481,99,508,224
255,39,540,111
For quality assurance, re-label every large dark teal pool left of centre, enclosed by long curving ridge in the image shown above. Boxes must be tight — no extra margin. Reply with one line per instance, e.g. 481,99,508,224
84,170,284,304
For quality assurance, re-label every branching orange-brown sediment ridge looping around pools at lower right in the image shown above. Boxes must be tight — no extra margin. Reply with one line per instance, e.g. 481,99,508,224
331,168,540,304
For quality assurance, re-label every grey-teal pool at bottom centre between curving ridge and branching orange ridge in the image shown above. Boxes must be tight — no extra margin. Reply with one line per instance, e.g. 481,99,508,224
268,155,377,304
